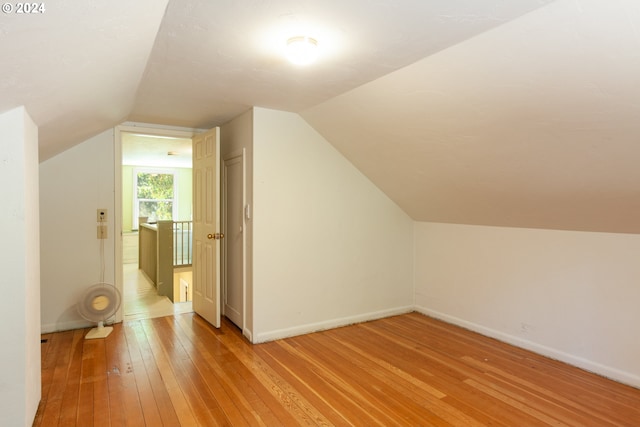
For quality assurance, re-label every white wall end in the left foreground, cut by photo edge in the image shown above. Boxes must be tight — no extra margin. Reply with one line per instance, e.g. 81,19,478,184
0,107,41,426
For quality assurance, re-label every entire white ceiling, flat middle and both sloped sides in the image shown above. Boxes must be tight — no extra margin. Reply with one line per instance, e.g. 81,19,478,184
0,0,640,233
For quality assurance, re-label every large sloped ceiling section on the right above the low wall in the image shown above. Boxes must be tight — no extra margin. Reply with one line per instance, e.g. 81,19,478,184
302,0,640,233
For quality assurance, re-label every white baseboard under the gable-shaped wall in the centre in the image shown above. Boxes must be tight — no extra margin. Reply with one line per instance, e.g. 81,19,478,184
253,306,414,344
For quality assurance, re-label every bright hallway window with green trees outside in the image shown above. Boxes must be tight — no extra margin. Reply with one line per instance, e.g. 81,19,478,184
133,169,177,228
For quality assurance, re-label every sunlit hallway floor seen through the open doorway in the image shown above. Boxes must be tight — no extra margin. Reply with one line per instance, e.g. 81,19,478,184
123,263,193,320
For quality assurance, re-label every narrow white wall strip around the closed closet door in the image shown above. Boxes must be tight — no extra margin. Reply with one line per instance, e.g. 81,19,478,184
220,109,253,341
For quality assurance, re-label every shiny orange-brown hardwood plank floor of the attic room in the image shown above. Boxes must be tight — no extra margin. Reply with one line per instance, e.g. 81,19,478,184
34,313,640,427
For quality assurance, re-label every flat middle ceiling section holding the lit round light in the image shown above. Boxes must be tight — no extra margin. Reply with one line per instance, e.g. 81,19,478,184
130,0,548,128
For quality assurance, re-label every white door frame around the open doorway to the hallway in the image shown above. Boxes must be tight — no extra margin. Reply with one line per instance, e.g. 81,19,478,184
113,123,203,322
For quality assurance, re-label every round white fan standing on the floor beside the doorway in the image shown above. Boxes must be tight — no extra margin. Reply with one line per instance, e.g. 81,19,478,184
78,283,122,340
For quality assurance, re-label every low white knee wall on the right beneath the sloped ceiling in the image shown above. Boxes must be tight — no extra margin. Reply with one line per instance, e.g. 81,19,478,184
415,223,640,387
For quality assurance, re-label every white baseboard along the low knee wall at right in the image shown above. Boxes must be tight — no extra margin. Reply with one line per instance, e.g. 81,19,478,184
415,306,640,388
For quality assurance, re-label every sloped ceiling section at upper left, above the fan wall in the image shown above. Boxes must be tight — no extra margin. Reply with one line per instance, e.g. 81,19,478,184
0,0,167,160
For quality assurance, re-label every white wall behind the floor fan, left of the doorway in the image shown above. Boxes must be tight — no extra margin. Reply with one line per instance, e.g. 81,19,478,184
40,129,119,332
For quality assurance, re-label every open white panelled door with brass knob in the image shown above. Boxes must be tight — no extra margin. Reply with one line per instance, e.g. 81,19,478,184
193,128,224,328
